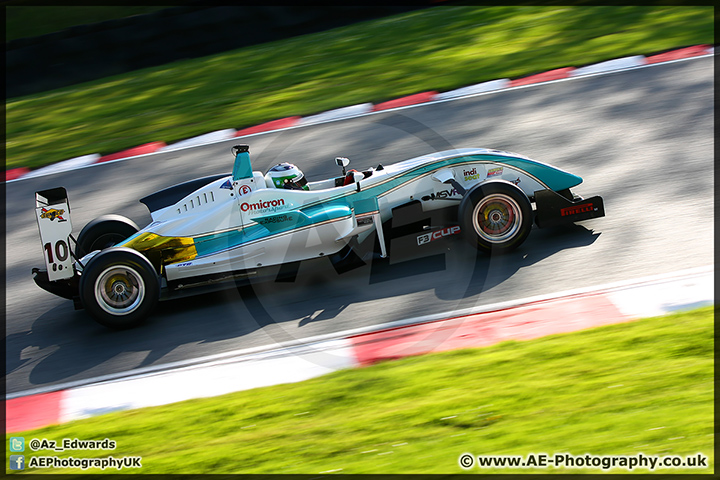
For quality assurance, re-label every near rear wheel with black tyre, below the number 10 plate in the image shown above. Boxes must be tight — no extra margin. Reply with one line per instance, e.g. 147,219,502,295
80,247,160,330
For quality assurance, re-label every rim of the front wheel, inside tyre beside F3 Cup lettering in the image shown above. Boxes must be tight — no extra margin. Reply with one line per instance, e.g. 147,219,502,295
473,193,523,243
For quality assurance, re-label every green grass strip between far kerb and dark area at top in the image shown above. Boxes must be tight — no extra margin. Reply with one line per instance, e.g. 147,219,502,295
6,6,714,168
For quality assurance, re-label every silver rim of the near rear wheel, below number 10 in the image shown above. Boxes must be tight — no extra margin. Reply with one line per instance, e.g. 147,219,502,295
95,265,145,315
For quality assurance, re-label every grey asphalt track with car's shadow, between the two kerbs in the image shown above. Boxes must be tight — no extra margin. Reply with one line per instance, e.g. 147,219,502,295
6,57,714,393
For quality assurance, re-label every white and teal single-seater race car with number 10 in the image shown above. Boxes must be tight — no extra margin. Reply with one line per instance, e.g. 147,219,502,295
32,145,605,329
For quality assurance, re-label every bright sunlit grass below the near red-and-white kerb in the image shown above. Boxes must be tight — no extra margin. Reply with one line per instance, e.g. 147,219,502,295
8,307,714,474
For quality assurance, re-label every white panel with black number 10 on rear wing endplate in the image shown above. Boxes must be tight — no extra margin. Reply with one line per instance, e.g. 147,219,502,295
35,203,73,281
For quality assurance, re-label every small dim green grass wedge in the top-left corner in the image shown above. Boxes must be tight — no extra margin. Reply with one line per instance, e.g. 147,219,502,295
5,6,168,42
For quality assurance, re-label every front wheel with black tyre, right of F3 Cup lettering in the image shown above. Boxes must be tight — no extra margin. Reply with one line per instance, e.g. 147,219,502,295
459,181,533,254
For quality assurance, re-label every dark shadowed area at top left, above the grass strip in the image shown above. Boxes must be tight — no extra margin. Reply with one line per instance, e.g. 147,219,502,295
6,2,434,97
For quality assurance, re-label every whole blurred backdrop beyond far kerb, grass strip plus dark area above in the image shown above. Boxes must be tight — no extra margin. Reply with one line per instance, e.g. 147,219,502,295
5,2,714,169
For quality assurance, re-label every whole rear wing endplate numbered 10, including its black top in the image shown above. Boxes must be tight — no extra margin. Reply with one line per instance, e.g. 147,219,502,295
35,187,74,281
